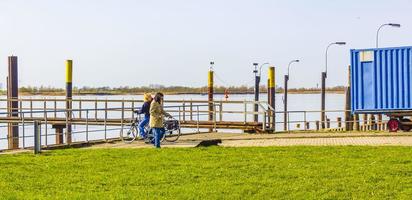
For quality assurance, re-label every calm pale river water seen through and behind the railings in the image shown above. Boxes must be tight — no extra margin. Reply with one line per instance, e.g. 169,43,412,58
0,94,345,149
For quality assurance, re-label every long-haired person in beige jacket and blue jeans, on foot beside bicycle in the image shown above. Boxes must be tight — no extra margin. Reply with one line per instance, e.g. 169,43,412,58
149,92,172,148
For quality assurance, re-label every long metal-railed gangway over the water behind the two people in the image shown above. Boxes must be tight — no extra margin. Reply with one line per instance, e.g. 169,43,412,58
0,98,271,149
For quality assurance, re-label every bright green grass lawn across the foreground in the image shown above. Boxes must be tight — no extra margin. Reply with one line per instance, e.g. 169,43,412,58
0,146,412,199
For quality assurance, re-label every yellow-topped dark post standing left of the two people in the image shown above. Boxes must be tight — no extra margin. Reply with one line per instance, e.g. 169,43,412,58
65,60,73,144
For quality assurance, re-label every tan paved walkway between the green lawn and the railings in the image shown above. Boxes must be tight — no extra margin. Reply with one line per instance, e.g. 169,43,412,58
0,132,412,155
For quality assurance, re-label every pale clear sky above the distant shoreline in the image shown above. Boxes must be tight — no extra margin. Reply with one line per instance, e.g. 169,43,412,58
0,0,412,87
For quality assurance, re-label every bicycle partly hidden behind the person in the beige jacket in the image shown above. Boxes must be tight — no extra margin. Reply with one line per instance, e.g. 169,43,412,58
123,112,181,143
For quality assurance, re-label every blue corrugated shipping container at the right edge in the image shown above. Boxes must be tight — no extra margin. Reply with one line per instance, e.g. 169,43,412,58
351,47,412,113
